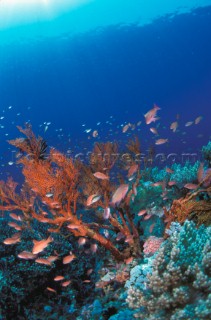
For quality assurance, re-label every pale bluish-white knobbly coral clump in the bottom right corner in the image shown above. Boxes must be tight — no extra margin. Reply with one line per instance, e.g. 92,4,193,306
127,221,211,320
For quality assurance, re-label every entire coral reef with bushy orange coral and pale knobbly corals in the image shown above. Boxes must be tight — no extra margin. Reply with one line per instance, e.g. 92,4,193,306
0,125,211,320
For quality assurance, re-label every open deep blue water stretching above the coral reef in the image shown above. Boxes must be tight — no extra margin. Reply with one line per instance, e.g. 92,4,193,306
0,1,211,178
